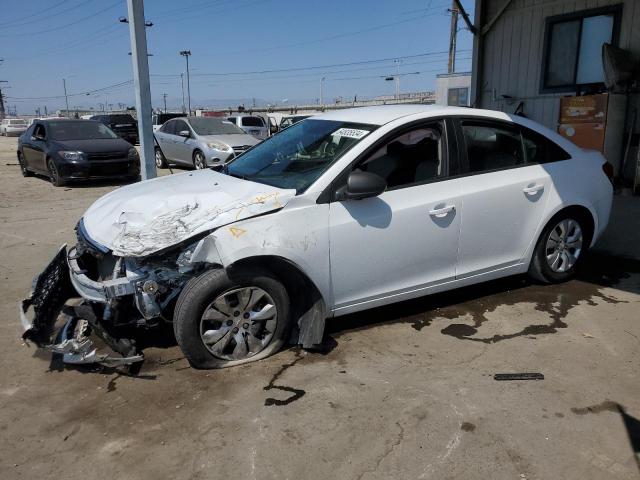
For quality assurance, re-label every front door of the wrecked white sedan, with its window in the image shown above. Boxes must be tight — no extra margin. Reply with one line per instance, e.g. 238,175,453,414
329,121,461,314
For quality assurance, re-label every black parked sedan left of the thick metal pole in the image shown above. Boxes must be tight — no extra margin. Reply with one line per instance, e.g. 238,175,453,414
17,119,140,187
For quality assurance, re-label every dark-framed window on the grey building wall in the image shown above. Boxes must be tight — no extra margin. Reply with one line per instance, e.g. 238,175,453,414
541,5,622,92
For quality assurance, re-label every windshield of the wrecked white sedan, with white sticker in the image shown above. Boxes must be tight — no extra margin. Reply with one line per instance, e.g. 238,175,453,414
227,120,375,193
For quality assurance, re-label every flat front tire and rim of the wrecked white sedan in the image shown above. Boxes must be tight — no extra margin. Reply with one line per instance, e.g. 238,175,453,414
173,268,290,368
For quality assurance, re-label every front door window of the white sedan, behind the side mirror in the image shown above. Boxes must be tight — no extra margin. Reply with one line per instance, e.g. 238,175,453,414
356,123,444,189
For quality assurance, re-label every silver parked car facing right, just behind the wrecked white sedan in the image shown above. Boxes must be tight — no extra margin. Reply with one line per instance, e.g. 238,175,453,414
155,117,260,169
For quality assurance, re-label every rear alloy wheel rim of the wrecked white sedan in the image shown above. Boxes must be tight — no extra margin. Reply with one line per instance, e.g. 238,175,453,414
545,218,583,273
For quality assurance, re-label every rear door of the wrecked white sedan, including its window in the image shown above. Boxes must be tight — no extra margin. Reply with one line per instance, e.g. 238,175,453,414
457,118,550,278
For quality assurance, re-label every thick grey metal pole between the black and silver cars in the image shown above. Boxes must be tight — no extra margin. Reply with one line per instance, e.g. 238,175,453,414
127,0,157,180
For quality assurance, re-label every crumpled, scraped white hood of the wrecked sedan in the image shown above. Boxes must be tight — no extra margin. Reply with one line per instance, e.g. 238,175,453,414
83,170,296,257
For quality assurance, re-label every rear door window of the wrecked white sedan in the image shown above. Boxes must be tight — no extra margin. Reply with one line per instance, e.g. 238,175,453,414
462,121,525,173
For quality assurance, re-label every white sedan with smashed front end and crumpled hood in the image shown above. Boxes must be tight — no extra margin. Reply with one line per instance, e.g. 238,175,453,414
23,105,613,368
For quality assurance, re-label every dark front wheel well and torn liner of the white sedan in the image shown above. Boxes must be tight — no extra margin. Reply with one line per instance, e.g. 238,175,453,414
227,255,327,348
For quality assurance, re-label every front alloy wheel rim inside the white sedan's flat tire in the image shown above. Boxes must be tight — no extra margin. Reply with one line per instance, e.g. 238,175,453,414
200,287,278,360
